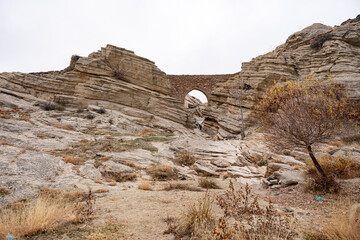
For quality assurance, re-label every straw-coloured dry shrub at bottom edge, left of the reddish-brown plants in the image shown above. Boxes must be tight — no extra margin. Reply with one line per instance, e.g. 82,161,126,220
164,193,216,239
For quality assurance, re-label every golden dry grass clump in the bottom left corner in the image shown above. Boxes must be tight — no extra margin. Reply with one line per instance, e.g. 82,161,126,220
0,196,77,239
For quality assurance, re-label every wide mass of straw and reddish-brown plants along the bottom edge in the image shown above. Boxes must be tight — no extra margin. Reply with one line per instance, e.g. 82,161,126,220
165,181,297,240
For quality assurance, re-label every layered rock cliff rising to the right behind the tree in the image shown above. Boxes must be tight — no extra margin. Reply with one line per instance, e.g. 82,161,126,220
204,21,360,138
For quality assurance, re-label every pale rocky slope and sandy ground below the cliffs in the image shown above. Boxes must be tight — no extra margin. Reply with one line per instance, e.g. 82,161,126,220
0,90,360,239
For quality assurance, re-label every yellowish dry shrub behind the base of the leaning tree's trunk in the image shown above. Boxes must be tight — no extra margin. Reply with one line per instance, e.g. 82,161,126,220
305,155,360,179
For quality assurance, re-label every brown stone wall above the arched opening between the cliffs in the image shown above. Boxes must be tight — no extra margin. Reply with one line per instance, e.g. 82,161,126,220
168,74,233,102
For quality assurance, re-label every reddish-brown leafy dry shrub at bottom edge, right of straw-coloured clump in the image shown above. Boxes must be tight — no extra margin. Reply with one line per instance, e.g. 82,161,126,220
214,181,296,240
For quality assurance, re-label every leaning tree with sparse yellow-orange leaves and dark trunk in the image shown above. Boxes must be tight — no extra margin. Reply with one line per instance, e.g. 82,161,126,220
255,76,357,178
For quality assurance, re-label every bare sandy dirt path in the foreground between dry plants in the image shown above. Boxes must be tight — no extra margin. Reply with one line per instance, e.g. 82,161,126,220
91,186,222,240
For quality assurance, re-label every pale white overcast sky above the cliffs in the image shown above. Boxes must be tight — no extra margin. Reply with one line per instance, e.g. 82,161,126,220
0,0,360,74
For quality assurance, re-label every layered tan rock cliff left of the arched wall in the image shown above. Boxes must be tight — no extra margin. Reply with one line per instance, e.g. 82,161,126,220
0,45,188,125
